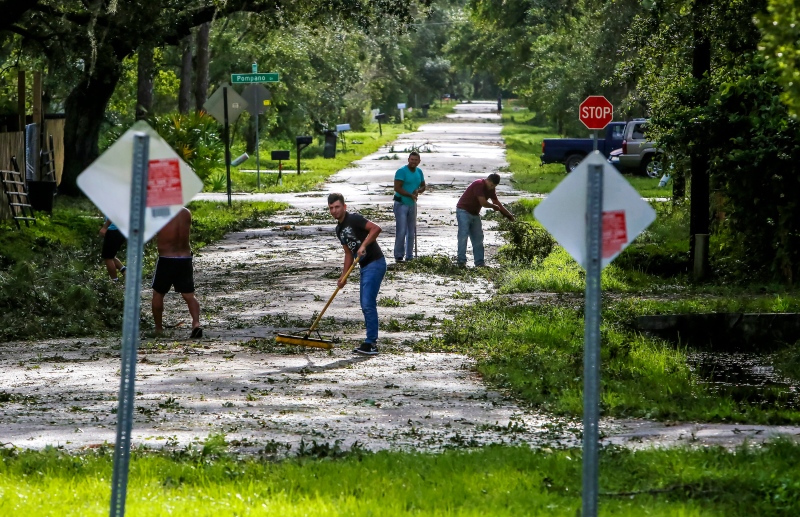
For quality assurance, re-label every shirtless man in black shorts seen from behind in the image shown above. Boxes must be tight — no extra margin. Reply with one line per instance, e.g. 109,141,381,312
153,208,203,339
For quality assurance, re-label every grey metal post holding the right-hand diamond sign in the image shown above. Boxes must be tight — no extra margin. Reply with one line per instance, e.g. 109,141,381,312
581,162,603,517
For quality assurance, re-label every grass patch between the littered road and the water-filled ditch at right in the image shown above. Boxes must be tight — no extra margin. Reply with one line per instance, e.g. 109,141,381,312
424,297,800,424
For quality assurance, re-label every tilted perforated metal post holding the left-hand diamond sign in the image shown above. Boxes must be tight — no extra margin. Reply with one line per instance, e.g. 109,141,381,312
111,133,150,517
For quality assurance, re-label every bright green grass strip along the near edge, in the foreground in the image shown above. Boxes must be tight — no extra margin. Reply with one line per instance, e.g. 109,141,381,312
0,441,800,517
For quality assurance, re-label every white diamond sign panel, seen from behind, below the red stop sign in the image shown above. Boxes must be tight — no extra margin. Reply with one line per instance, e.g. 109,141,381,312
533,151,656,269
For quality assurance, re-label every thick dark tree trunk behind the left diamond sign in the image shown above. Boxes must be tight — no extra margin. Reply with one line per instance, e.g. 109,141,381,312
59,51,122,196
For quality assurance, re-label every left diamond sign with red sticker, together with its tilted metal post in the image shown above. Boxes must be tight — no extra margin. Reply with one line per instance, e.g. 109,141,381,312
77,121,203,517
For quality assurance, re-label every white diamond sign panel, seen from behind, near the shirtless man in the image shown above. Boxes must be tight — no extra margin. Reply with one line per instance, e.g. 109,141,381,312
78,121,203,242
